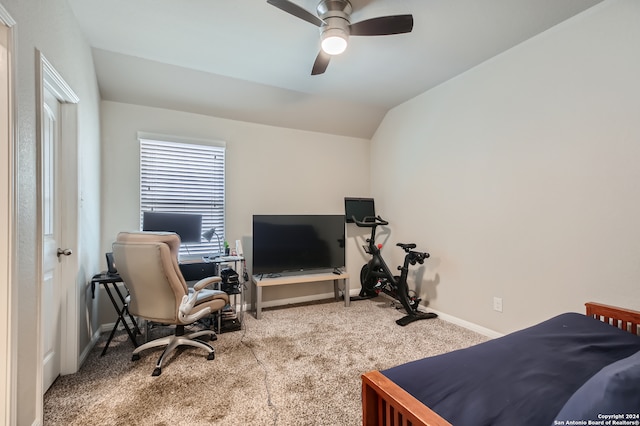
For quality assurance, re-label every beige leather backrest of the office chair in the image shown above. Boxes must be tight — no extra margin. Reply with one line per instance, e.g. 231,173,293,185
113,232,188,323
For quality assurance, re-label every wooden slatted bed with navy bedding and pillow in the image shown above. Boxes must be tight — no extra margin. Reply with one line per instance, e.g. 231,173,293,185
362,302,640,426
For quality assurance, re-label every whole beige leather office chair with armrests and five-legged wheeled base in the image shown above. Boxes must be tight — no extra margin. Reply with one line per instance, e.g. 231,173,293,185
113,232,229,376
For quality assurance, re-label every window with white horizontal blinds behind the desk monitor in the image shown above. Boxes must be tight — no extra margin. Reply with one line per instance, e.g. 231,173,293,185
139,134,225,257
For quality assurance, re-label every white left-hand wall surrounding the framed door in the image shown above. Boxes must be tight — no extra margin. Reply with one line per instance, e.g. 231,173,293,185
1,0,100,425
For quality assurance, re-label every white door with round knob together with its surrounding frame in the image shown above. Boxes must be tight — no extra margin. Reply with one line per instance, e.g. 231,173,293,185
36,51,79,402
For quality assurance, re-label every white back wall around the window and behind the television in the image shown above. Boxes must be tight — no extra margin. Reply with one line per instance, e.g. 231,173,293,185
101,101,369,320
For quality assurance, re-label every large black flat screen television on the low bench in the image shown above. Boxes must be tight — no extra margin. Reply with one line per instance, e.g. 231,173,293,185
253,215,345,275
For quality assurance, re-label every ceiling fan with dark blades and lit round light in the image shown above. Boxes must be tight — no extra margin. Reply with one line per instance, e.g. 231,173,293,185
267,0,413,75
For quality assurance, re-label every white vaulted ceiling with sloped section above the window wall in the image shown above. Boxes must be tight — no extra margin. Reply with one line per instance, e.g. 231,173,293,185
68,0,602,138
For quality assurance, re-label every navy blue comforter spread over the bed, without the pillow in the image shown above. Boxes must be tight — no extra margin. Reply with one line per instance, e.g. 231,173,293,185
382,313,640,426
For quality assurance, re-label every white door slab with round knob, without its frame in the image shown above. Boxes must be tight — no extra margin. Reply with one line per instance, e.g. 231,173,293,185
40,88,68,393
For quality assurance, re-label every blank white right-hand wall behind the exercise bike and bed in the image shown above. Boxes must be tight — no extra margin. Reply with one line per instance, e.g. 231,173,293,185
371,0,640,332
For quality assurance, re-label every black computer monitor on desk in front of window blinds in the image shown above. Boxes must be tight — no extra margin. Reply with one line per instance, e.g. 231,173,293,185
142,212,202,243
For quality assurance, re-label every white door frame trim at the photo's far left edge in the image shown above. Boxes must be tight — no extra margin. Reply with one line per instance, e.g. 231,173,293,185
0,4,17,425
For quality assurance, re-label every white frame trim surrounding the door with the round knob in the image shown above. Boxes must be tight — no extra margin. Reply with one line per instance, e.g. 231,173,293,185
36,49,80,404
